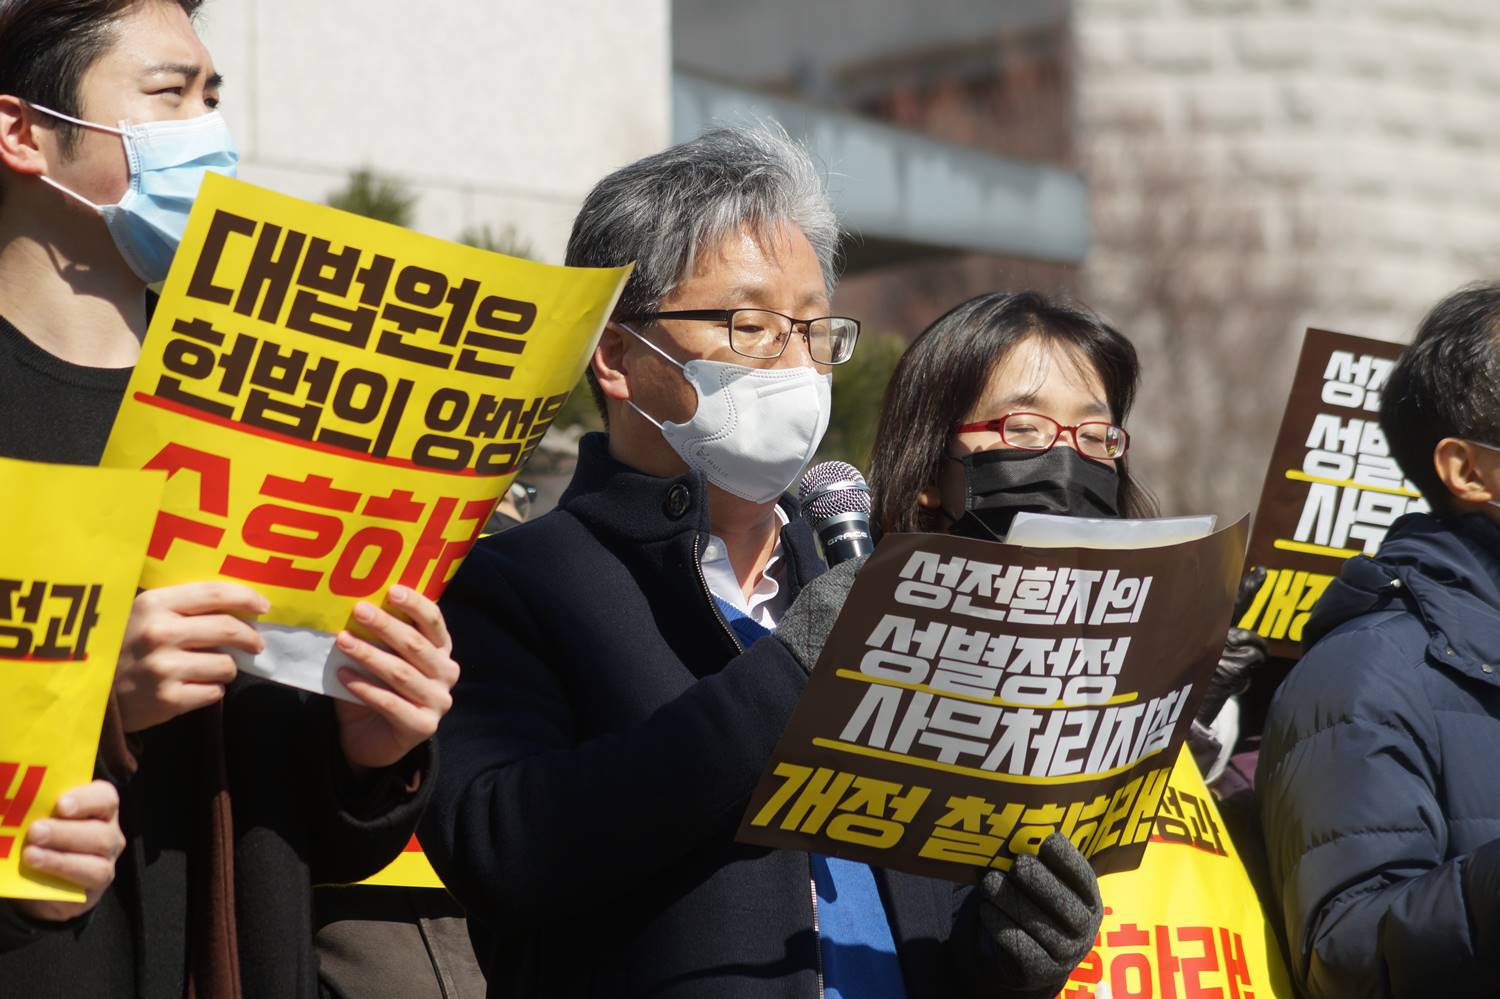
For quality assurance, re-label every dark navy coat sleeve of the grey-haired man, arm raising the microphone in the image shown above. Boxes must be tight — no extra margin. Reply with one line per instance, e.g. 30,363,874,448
422,557,806,926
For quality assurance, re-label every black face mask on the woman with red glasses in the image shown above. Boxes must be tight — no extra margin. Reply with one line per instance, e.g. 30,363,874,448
948,447,1121,542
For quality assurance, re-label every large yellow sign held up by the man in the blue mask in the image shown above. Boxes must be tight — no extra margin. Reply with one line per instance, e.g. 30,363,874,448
104,174,629,693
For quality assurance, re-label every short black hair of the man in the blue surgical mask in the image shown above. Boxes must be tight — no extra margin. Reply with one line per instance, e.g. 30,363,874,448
0,0,203,153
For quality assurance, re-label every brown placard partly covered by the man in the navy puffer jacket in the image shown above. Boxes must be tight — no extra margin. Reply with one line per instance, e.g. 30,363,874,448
1238,330,1428,659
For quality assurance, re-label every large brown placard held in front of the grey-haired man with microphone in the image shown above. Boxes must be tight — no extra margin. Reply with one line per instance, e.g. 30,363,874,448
738,519,1247,882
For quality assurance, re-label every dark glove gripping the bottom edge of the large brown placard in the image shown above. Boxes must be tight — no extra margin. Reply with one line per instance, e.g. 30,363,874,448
978,833,1104,996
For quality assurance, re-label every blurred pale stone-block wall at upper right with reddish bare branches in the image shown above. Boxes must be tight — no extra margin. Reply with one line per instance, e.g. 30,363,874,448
1073,0,1500,516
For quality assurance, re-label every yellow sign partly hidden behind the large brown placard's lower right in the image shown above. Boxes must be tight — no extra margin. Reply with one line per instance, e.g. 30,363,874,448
1059,746,1293,999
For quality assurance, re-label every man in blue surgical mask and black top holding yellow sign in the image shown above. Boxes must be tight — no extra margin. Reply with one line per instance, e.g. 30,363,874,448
0,0,458,998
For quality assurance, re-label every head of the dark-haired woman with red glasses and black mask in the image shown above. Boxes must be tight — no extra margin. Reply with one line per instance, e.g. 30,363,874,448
870,291,1155,540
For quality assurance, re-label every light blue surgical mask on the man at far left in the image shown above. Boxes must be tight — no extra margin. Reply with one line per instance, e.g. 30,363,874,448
32,104,240,285
